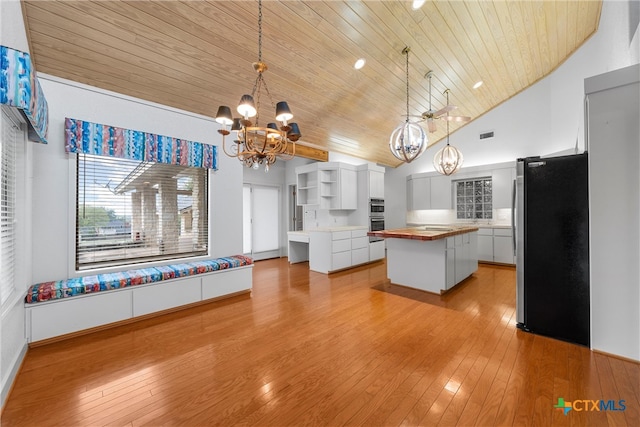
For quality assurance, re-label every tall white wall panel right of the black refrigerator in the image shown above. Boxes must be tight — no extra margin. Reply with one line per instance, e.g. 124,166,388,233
585,65,640,361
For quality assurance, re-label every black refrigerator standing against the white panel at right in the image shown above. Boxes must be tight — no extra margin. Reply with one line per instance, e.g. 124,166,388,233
513,152,590,346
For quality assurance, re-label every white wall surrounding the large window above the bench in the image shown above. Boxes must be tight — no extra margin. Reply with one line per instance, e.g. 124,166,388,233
33,74,242,282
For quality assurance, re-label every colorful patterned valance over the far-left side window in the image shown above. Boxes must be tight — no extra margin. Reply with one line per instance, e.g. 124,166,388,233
0,46,49,144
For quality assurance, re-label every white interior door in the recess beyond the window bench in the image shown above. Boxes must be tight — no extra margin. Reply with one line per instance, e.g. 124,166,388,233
243,184,280,260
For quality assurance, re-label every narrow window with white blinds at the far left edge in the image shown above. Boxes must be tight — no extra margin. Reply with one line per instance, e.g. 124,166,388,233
0,109,21,305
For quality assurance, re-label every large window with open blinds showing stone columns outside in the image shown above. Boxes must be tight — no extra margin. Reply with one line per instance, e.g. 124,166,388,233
76,154,209,270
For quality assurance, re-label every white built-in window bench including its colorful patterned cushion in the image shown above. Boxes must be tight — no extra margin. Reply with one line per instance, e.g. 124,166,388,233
25,255,253,343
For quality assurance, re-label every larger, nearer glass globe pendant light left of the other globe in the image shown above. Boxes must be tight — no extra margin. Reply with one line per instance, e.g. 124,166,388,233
389,47,427,163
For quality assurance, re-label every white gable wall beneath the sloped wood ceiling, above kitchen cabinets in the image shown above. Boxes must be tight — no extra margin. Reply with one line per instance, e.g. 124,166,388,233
385,0,640,228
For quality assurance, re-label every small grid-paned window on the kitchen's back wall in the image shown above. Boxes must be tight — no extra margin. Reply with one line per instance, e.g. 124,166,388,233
455,177,493,220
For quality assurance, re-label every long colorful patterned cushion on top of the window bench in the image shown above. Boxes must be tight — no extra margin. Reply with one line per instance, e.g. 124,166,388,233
25,255,253,304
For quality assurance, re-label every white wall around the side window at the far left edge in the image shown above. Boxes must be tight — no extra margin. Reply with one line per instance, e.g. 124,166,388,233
0,0,35,406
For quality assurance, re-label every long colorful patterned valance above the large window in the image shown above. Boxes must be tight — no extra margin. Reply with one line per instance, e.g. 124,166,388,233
64,118,218,169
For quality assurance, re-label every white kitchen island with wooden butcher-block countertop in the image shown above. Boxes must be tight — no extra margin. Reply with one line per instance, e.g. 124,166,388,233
368,225,478,294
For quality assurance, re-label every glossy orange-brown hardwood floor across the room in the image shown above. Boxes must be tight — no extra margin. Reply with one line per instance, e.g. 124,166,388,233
2,258,640,426
